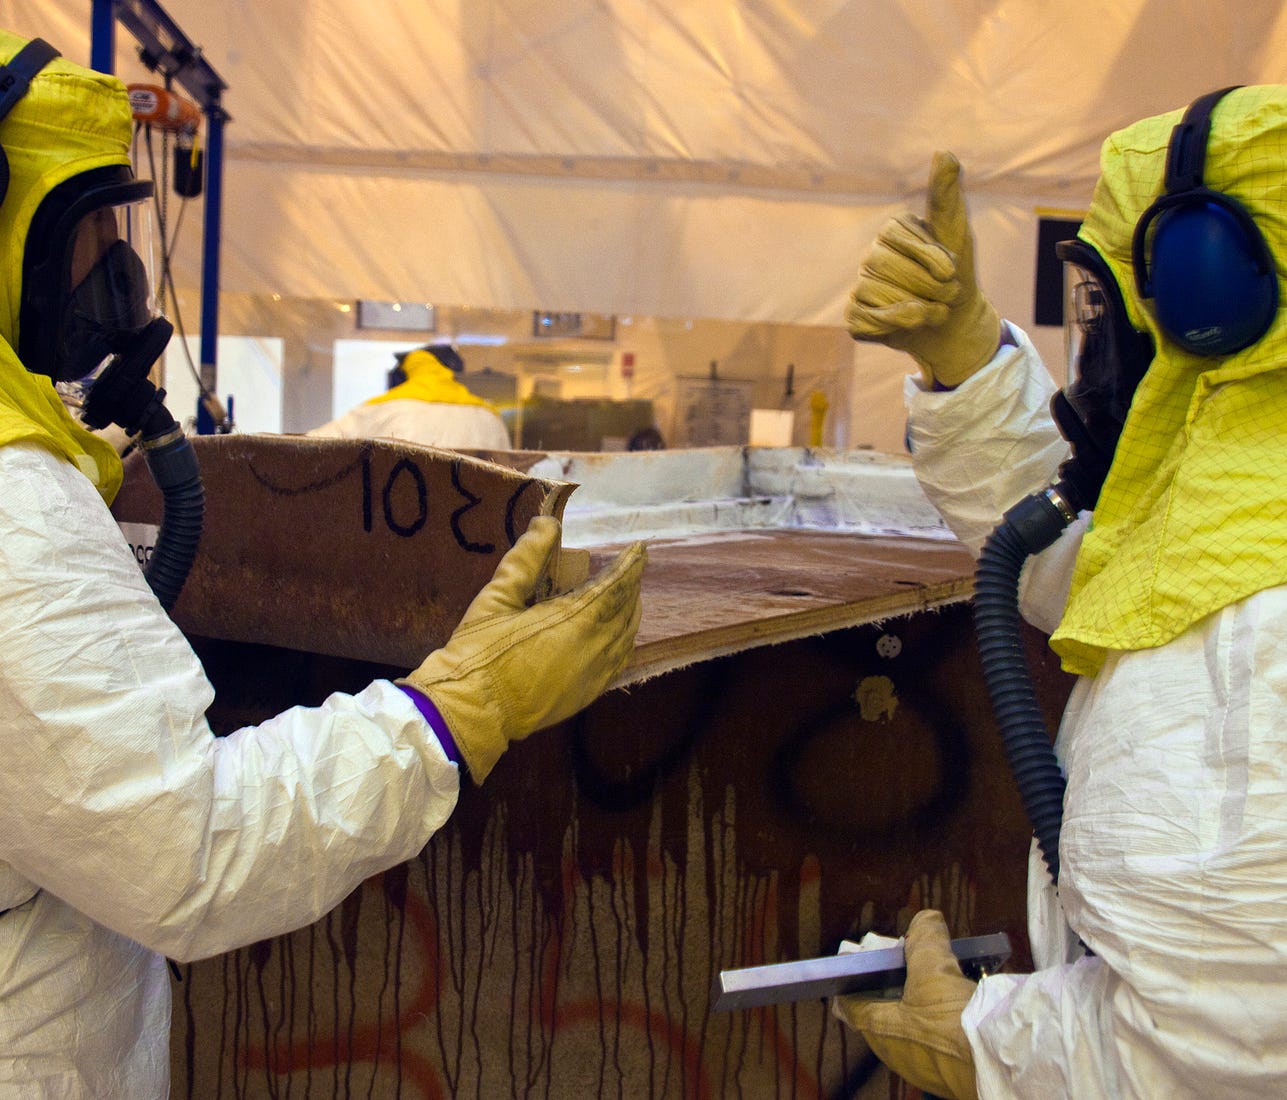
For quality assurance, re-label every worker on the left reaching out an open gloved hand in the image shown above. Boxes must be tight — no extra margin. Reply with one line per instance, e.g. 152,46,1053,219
0,32,644,1100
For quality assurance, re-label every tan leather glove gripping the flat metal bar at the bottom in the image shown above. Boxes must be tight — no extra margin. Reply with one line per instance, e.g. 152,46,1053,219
831,910,978,1100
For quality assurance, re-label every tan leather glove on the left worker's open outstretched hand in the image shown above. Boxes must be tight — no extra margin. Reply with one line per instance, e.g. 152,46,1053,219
404,516,645,782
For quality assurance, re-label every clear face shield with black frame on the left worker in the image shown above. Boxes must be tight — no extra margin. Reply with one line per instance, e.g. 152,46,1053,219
19,166,161,387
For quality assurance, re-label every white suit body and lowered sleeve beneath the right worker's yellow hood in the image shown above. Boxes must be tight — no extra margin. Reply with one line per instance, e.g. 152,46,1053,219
961,587,1287,1100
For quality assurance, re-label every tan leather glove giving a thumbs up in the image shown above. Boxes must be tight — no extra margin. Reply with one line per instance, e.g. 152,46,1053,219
844,153,1001,389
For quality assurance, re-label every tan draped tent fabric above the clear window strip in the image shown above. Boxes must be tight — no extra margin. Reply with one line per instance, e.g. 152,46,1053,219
0,0,1287,324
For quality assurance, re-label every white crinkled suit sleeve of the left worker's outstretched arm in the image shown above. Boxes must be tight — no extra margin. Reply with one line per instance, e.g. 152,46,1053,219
0,445,459,960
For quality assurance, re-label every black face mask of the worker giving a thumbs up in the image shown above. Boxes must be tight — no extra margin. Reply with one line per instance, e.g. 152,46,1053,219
1051,241,1154,495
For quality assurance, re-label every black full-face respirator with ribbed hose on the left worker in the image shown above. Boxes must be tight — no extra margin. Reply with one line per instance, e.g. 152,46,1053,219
0,39,205,610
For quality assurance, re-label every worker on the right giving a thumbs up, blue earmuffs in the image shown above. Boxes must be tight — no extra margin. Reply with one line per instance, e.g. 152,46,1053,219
834,86,1287,1100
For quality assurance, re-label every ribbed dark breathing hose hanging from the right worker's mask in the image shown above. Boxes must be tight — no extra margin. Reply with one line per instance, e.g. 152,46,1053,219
974,482,1076,884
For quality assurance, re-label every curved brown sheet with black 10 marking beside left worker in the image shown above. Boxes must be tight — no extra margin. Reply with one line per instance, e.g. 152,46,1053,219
112,435,574,668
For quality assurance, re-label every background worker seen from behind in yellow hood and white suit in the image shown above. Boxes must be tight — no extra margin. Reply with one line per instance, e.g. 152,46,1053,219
309,344,511,450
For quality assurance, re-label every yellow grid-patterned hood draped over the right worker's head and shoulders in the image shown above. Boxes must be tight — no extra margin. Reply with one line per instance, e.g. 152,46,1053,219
1051,85,1287,674
